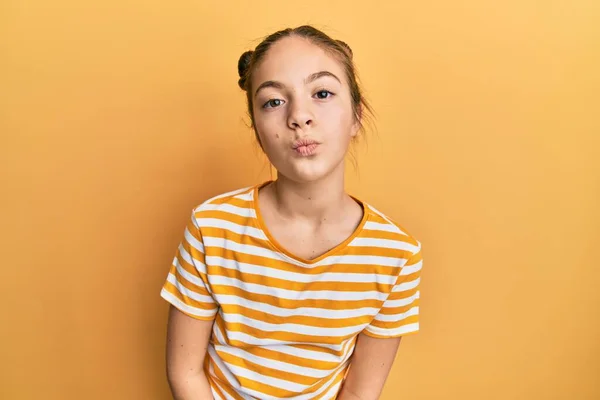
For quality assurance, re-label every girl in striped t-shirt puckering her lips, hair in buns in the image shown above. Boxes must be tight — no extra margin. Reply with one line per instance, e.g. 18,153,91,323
161,26,421,400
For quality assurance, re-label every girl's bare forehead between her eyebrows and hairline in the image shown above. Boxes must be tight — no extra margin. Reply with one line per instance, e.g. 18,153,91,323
252,37,342,82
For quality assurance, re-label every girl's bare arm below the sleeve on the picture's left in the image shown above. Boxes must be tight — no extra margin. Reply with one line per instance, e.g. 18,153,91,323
167,306,214,400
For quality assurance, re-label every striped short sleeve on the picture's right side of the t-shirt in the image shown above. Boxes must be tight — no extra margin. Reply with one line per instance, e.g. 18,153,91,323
363,246,423,339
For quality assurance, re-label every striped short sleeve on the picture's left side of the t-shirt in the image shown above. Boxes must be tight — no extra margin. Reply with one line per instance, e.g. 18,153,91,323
160,208,218,320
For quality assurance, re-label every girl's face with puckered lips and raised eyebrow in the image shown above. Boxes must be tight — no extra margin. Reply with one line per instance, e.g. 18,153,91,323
251,36,360,182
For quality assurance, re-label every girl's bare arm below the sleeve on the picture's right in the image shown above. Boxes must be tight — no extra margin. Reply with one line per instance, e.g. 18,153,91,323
337,333,401,400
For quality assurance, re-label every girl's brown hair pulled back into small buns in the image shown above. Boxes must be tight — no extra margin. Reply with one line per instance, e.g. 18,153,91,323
238,25,373,143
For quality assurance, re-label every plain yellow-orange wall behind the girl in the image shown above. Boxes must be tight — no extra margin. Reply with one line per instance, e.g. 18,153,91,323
0,0,600,400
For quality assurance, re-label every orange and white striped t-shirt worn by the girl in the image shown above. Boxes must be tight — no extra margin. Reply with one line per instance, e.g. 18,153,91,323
161,182,422,400
